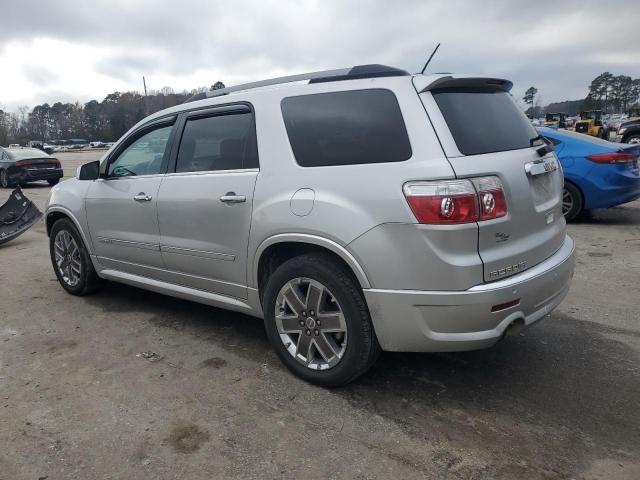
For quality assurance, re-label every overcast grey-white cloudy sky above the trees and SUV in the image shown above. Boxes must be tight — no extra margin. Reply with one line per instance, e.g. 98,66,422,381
0,0,640,110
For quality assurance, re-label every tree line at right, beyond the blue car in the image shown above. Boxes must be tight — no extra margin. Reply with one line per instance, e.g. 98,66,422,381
522,72,640,117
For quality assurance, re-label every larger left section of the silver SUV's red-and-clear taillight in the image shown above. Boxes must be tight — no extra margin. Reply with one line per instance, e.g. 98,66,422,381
404,180,478,224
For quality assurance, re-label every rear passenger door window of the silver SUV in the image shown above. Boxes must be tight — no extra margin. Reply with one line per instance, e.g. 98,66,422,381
176,113,258,172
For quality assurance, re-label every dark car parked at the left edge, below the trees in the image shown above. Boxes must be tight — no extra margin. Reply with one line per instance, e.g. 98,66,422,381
0,147,64,188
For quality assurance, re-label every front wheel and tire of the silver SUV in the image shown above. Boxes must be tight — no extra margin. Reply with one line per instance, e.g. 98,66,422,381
49,218,102,296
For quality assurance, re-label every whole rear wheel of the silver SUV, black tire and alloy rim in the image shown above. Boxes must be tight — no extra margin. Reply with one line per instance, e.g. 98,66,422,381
263,253,380,387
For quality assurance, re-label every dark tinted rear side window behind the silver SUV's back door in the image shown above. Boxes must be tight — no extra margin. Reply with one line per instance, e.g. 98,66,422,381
282,89,411,167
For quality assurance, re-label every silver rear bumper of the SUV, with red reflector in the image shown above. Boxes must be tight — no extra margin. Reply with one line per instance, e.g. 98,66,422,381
364,235,575,352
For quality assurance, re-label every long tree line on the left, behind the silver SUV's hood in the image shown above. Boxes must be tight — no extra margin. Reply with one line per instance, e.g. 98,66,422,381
0,81,224,145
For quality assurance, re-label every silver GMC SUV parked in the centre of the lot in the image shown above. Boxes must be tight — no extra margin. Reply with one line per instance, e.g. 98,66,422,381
46,65,574,386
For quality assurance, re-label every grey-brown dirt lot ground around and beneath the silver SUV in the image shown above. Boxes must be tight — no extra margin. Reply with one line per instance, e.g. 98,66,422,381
0,153,640,480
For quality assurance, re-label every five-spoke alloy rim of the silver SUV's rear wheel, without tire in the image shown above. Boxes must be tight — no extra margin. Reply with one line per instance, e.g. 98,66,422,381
275,278,347,370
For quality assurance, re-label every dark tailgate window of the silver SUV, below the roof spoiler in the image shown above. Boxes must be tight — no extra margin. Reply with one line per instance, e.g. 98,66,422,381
432,89,537,155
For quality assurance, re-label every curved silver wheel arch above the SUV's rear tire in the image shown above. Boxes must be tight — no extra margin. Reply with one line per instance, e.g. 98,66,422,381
251,234,371,298
